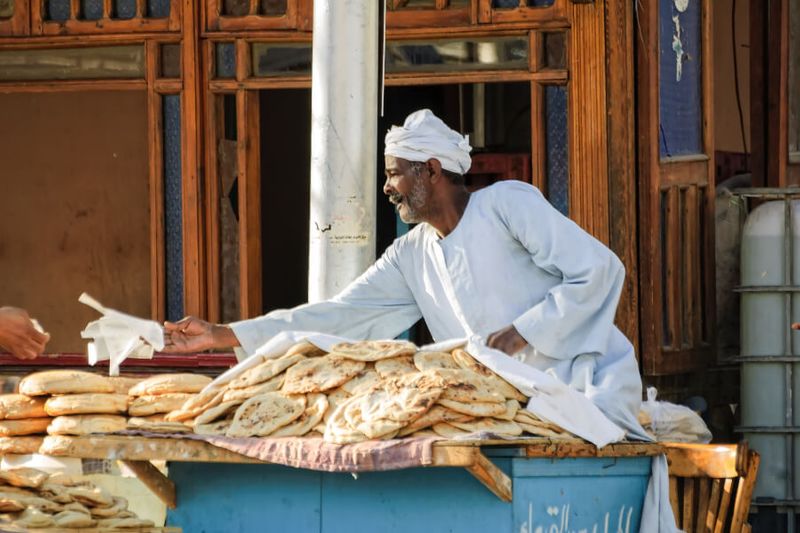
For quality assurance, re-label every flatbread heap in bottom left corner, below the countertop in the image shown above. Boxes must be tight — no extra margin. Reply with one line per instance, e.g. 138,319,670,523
0,468,153,531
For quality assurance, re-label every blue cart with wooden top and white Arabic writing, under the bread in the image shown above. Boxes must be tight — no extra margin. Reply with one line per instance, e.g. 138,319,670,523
36,435,663,533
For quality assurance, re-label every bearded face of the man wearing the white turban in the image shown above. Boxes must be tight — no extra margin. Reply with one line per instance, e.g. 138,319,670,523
383,155,430,224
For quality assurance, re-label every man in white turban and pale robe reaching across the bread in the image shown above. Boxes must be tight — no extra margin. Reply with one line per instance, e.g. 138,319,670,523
165,109,646,438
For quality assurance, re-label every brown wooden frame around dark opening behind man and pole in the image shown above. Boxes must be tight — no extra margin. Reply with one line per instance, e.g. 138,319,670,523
203,11,620,321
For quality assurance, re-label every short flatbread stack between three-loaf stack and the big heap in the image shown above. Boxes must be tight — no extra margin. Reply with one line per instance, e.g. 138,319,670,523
128,373,211,433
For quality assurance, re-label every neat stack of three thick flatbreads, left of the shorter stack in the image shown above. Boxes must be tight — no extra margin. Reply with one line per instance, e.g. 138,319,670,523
14,370,128,435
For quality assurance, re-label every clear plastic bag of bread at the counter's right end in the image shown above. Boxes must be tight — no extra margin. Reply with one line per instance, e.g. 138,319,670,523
639,387,711,444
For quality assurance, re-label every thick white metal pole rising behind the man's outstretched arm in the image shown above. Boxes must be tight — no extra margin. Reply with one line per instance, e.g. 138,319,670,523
308,0,379,302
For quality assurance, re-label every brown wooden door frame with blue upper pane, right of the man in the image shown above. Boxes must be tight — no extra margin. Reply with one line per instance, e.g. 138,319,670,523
636,0,715,375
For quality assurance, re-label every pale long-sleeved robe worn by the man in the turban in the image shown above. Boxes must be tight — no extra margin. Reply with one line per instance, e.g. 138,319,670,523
231,181,643,436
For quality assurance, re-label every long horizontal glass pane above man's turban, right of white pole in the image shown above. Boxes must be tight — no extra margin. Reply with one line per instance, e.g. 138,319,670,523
386,37,528,73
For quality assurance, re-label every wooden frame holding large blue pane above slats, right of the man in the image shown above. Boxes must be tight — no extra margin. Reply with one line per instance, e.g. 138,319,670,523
637,0,716,375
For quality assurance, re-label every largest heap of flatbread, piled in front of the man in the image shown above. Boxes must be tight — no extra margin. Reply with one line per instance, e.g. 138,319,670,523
165,341,574,444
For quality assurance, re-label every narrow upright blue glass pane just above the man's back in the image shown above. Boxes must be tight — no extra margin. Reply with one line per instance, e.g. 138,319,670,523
544,85,569,216
